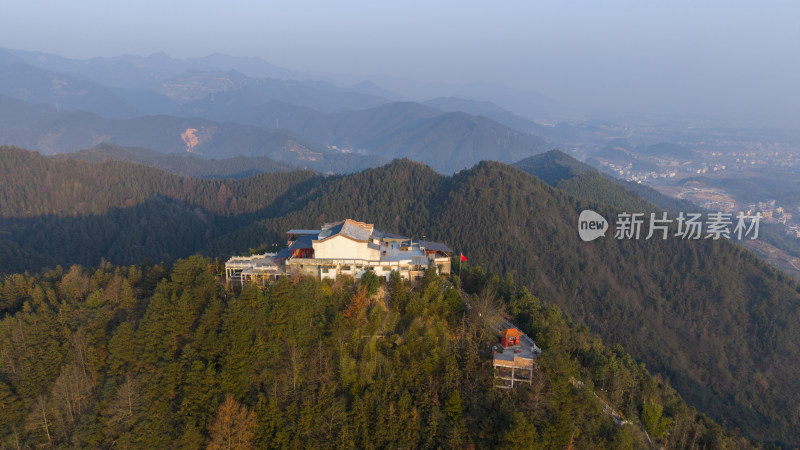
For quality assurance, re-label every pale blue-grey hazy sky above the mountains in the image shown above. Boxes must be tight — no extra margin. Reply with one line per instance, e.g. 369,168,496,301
0,0,800,120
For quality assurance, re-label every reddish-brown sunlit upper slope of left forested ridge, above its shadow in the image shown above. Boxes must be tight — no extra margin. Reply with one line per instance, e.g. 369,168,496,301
0,147,319,218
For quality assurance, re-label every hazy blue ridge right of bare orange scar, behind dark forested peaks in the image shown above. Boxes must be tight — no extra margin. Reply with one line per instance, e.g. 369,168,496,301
188,100,549,172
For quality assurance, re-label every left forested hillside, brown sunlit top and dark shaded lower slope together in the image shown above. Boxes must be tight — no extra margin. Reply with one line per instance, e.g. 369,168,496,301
0,147,318,272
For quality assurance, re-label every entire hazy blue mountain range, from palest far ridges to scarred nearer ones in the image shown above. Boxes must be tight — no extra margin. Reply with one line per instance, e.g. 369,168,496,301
0,45,552,173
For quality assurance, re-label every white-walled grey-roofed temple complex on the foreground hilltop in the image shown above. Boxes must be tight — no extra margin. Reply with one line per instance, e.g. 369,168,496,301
225,219,452,283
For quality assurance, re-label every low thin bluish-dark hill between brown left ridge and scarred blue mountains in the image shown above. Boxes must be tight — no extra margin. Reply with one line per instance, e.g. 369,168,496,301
53,144,297,178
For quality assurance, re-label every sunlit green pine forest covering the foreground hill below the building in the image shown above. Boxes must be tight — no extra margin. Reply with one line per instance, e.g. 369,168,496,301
0,257,752,448
